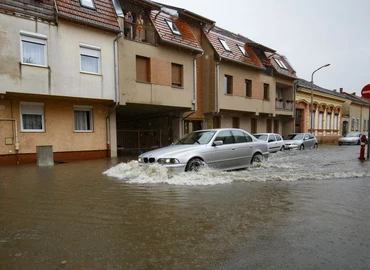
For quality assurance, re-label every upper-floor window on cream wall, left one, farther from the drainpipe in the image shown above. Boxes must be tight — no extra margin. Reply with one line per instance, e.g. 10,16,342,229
20,31,47,66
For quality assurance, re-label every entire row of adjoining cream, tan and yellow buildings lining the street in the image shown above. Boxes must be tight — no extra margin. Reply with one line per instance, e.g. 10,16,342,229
0,0,369,164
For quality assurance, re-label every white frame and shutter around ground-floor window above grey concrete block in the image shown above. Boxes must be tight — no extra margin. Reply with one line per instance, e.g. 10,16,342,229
19,101,45,132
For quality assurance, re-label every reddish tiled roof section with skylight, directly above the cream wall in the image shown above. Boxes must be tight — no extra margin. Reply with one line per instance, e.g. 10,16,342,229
56,0,120,32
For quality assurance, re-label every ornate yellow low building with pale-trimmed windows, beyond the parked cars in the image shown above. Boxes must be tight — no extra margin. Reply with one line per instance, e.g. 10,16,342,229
295,79,347,143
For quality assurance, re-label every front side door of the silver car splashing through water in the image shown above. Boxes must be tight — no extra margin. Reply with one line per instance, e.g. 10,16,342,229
208,130,237,170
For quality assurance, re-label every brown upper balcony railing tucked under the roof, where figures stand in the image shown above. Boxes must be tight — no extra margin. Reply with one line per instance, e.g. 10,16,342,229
124,22,158,45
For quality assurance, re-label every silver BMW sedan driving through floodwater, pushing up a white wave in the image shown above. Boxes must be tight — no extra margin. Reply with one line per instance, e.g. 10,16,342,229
138,128,269,172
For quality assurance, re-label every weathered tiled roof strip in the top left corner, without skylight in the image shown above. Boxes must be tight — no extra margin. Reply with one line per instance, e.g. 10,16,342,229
0,0,55,21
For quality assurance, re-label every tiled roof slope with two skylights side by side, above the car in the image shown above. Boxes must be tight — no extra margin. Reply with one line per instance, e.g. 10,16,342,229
204,27,264,69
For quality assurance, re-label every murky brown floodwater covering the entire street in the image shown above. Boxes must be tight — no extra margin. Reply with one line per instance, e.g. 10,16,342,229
0,146,370,270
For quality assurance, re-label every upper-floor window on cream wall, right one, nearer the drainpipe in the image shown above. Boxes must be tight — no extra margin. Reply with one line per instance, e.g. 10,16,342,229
80,44,100,74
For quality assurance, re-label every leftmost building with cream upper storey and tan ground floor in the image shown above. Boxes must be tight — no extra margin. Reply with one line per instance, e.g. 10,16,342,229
0,0,120,164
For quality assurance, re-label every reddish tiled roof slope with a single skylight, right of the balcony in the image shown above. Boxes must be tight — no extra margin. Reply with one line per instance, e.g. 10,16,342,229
149,10,203,52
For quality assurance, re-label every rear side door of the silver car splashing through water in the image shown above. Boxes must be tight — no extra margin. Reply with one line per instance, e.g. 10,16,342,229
231,130,253,168
